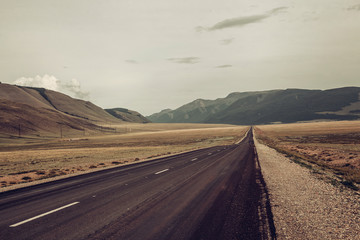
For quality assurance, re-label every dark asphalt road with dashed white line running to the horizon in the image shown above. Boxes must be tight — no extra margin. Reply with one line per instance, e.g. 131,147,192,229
0,131,276,240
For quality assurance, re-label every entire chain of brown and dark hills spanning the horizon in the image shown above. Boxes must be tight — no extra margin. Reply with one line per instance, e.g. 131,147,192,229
0,83,360,136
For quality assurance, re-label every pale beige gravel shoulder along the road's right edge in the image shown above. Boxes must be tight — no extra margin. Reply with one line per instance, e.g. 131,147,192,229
255,136,360,240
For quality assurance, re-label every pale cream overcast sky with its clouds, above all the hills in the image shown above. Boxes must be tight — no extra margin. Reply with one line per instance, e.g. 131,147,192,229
0,0,360,115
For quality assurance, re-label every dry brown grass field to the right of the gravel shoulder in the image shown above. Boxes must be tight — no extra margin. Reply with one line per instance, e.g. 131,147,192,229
255,121,360,189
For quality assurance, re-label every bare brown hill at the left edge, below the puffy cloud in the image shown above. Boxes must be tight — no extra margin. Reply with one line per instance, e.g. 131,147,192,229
0,83,146,136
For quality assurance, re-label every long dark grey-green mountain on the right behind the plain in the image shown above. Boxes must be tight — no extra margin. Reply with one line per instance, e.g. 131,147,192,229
147,87,360,125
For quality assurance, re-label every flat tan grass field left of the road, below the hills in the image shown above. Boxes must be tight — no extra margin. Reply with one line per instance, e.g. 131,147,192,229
0,123,248,188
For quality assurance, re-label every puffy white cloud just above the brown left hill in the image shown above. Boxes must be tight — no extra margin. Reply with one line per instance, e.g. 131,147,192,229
14,74,89,99
